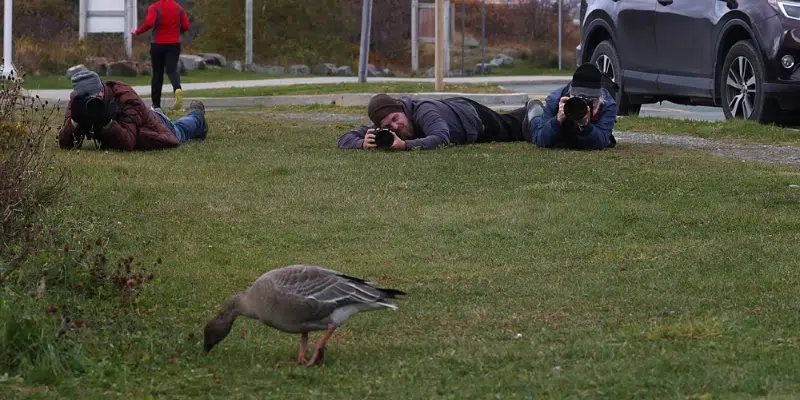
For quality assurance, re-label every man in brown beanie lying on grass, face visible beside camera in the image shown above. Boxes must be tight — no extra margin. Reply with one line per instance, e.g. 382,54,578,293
337,94,531,151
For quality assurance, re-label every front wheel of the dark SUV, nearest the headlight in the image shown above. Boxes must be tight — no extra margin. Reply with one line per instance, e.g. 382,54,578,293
718,40,775,123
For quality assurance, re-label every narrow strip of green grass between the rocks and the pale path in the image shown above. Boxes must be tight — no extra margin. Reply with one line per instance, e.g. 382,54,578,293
24,68,300,90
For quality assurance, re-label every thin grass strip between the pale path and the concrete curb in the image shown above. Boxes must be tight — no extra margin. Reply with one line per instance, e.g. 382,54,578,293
173,82,509,97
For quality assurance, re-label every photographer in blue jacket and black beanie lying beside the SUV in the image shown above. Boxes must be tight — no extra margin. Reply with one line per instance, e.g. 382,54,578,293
526,63,617,150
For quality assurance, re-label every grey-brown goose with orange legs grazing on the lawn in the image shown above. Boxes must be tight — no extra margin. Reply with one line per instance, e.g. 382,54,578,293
204,264,406,366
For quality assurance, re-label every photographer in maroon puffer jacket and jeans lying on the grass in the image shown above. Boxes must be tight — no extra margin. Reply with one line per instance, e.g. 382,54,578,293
58,71,208,150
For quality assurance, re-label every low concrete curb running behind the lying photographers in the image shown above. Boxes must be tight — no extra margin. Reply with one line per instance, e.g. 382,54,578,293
40,92,528,109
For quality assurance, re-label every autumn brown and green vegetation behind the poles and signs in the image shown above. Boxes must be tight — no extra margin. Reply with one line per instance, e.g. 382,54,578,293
0,0,578,75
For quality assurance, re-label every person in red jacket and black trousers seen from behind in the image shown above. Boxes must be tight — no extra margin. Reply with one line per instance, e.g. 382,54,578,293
131,0,190,110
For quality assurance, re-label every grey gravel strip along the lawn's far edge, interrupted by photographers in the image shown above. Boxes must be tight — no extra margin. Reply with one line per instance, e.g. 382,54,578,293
247,111,800,165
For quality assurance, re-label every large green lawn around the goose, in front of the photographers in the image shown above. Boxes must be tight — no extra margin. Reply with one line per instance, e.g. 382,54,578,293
6,110,800,399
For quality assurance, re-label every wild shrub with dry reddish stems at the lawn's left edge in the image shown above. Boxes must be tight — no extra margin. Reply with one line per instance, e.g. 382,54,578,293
0,65,160,384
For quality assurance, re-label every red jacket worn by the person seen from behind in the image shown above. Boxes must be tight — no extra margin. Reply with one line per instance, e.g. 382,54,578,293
133,0,189,44
